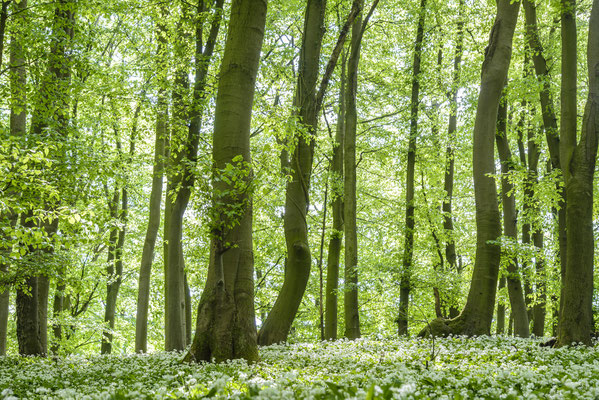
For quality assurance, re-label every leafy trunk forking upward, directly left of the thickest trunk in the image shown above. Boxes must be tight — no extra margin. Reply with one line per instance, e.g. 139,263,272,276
164,0,223,350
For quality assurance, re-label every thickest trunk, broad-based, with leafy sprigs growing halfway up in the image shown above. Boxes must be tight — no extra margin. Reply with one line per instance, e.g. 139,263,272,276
185,0,267,361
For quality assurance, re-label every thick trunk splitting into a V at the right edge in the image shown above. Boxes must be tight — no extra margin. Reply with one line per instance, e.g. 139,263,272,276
557,0,599,346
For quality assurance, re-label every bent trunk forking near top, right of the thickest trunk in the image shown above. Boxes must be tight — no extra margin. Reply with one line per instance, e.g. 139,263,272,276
258,0,360,345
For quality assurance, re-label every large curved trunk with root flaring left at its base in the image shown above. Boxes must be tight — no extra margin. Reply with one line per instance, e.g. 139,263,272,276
421,0,520,335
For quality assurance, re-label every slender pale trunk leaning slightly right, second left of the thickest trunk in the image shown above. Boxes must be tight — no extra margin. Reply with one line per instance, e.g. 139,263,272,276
135,8,168,353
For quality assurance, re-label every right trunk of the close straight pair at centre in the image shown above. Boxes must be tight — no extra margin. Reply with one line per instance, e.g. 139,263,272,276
343,4,362,339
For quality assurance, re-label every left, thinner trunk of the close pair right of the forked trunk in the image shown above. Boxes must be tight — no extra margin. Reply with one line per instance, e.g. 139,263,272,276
325,54,346,339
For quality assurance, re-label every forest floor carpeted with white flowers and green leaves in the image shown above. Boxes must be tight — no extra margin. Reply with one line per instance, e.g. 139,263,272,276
0,336,599,399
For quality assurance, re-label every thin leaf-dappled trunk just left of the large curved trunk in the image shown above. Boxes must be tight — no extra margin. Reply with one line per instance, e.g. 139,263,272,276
443,0,464,318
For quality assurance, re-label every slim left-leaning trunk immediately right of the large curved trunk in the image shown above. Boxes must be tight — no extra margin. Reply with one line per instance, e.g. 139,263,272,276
495,90,530,337
